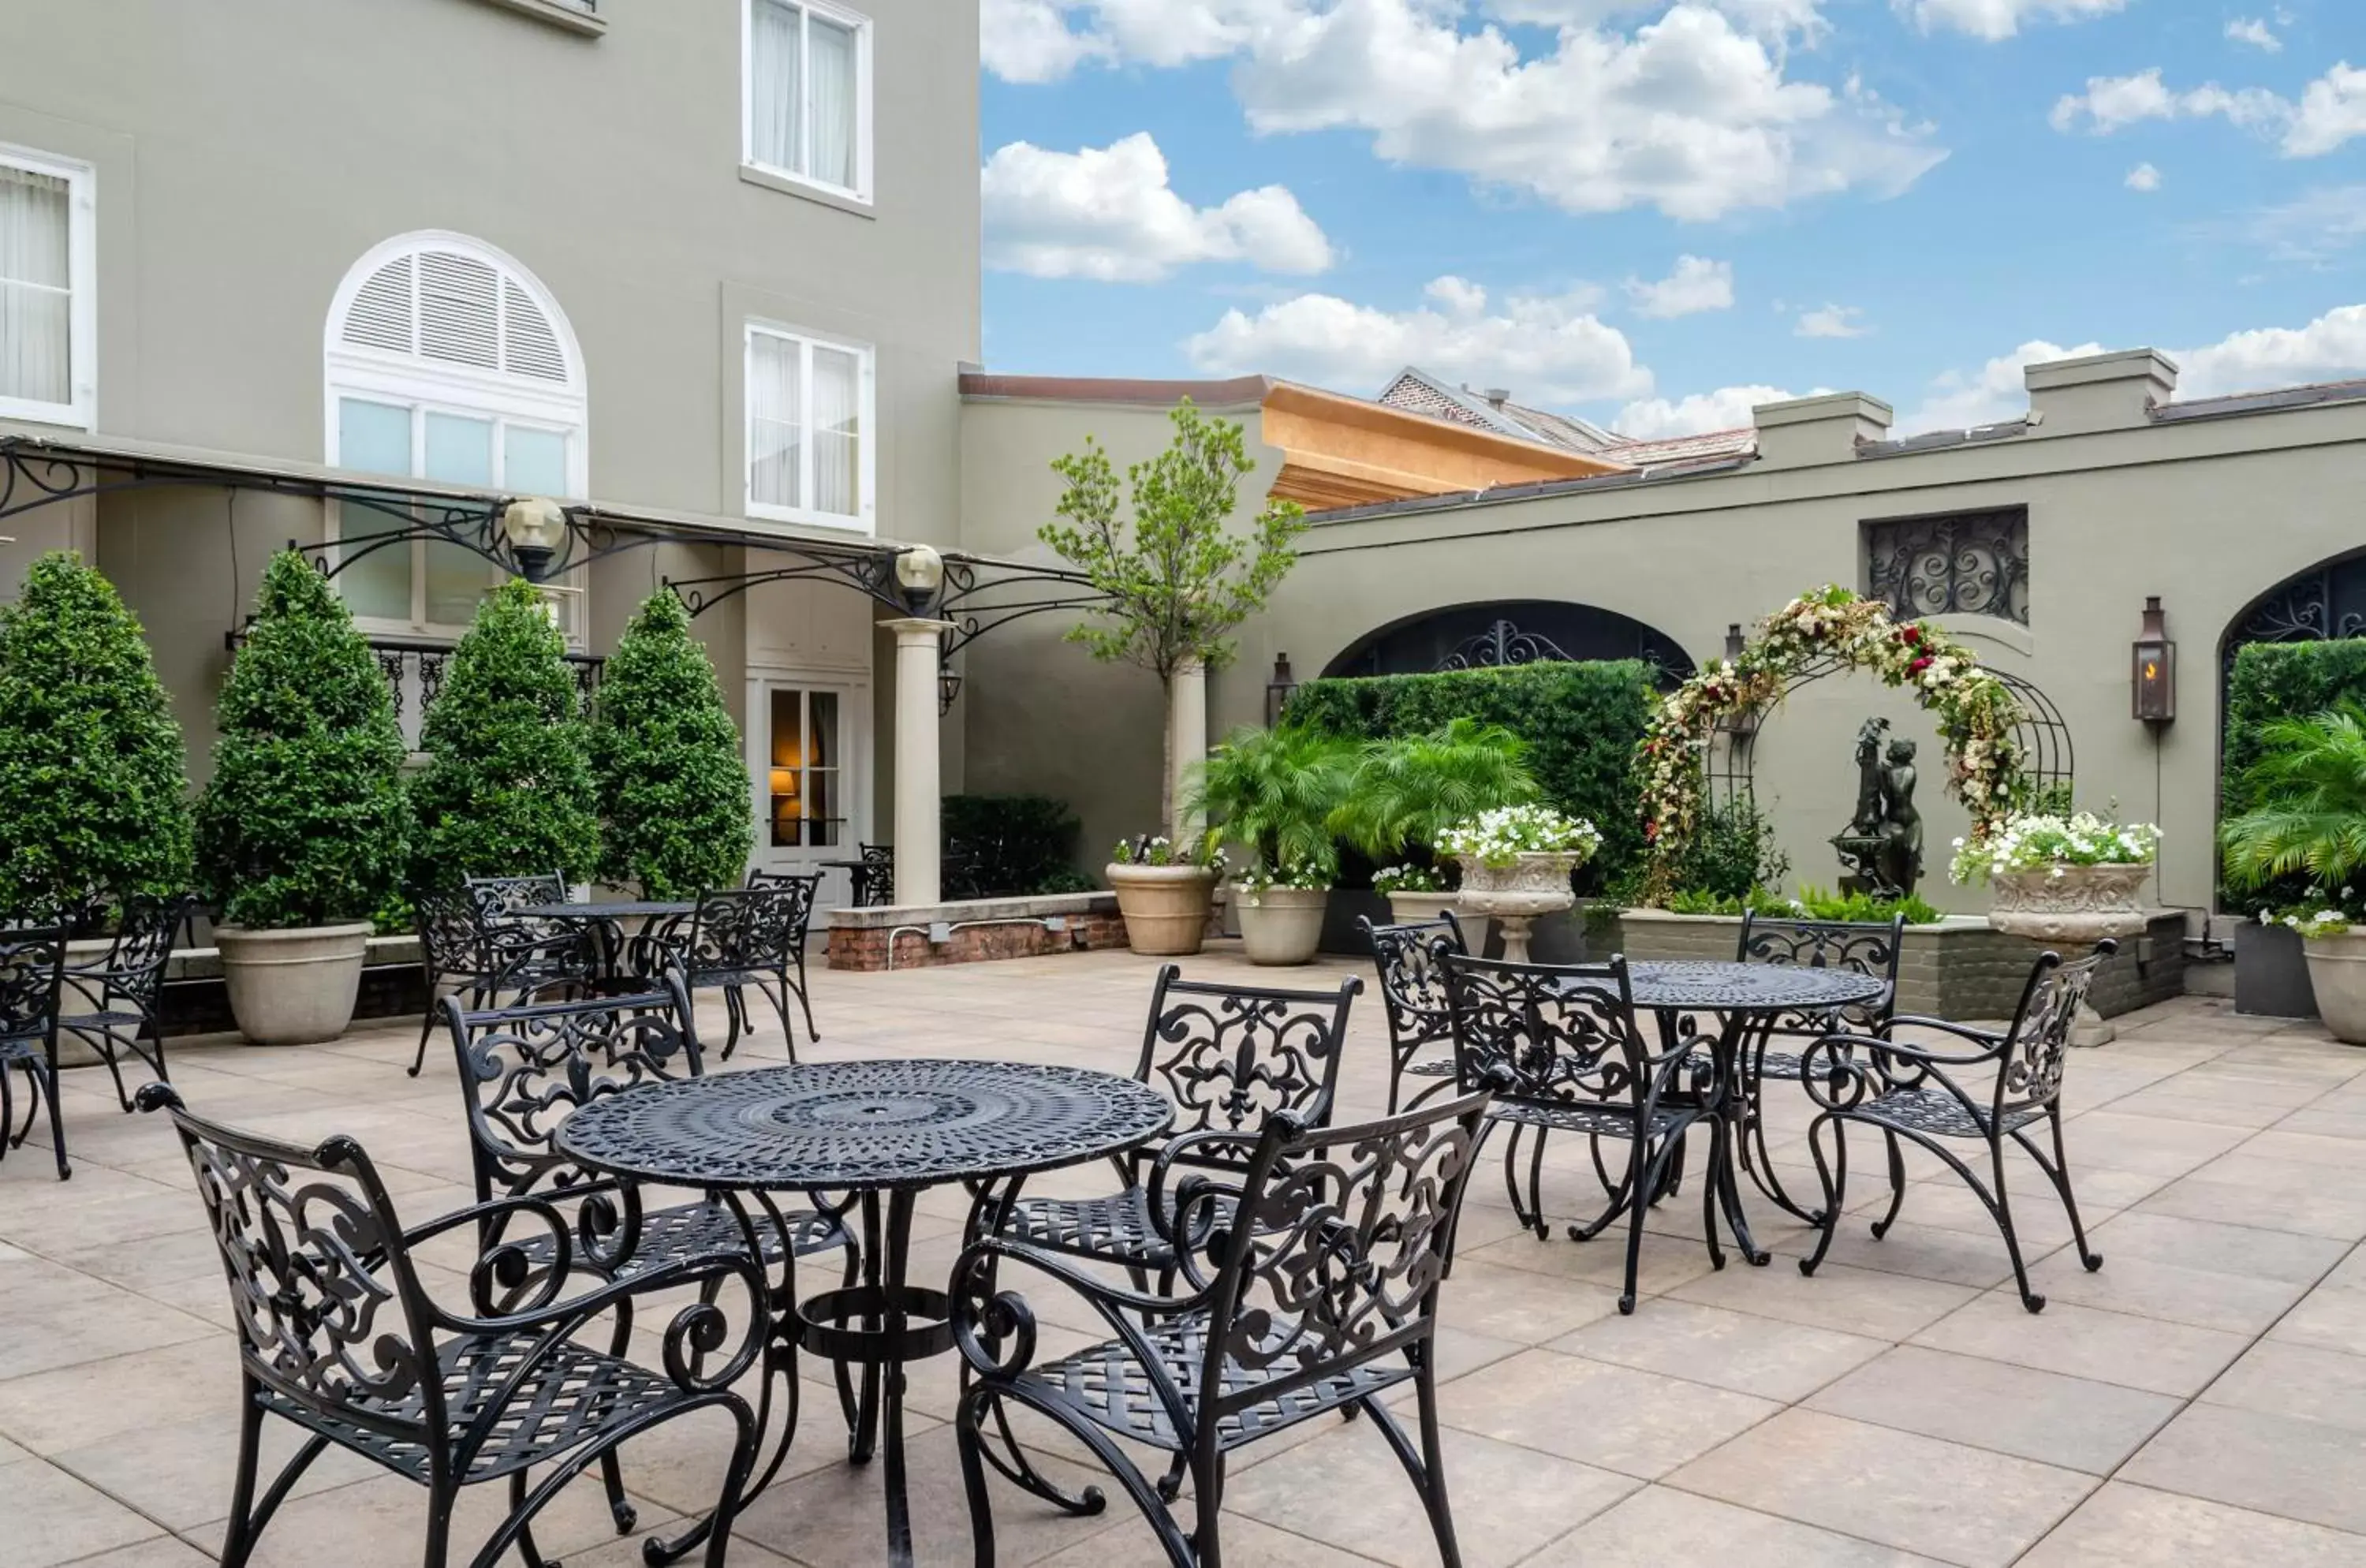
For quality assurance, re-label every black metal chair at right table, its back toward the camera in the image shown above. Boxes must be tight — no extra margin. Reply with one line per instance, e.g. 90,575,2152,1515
1436,950,1725,1312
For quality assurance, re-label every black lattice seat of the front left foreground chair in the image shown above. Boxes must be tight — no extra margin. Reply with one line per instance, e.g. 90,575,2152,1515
263,1331,696,1483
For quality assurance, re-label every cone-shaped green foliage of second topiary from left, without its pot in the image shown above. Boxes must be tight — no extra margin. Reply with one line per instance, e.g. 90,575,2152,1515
196,551,409,929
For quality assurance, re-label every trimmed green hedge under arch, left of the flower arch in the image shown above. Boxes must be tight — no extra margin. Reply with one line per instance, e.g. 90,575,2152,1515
1287,660,1654,891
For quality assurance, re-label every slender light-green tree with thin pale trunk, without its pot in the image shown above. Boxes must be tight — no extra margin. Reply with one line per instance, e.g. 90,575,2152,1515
1039,398,1306,842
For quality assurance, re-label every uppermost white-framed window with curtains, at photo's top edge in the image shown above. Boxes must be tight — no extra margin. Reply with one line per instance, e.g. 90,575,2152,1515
741,0,871,201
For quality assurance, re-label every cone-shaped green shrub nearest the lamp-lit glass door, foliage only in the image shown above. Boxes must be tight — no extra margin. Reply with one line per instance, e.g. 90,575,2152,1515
592,589,755,898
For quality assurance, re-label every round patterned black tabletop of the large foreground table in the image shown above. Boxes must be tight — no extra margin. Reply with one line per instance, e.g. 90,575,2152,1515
558,1059,1174,1192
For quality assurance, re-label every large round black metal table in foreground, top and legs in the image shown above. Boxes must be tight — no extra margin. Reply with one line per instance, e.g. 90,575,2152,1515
556,1059,1174,1566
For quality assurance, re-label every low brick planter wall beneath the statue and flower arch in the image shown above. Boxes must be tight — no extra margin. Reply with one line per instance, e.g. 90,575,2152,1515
1618,908,2186,1021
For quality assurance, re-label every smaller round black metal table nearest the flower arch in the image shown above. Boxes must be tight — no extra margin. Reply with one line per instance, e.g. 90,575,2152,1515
1628,960,1881,1265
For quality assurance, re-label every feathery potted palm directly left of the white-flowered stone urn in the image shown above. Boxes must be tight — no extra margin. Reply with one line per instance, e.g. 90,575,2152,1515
1330,719,1540,922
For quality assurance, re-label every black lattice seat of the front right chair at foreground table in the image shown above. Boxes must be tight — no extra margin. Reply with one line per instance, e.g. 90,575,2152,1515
1020,1312,1413,1452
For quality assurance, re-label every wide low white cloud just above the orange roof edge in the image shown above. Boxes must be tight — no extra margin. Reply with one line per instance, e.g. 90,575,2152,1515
1183,277,1651,405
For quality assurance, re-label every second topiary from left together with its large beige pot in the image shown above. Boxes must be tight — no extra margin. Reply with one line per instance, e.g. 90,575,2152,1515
196,551,409,1045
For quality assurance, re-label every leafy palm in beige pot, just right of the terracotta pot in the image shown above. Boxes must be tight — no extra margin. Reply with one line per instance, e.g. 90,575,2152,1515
1185,726,1353,965
